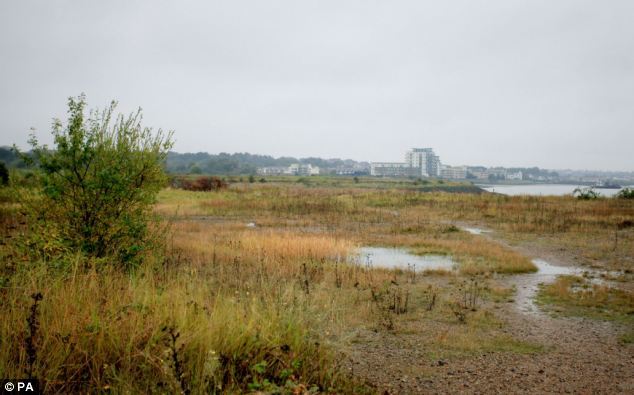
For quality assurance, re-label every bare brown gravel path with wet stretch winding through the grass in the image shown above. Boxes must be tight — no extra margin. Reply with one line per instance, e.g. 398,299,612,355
350,226,634,394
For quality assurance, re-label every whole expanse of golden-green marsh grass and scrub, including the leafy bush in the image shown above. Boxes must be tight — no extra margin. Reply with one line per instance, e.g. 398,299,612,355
0,98,634,393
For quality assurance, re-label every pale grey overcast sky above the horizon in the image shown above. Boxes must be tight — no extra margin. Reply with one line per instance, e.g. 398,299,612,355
0,0,634,171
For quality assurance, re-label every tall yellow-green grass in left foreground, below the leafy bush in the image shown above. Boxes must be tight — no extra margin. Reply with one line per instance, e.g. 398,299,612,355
0,256,362,393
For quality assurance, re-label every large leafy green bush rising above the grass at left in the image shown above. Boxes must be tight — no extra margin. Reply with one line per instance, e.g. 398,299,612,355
21,95,172,266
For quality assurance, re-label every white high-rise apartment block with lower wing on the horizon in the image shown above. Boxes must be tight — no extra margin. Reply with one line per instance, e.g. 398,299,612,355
370,148,441,177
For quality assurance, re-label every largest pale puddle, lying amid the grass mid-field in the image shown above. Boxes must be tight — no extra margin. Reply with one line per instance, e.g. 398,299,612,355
351,247,456,271
